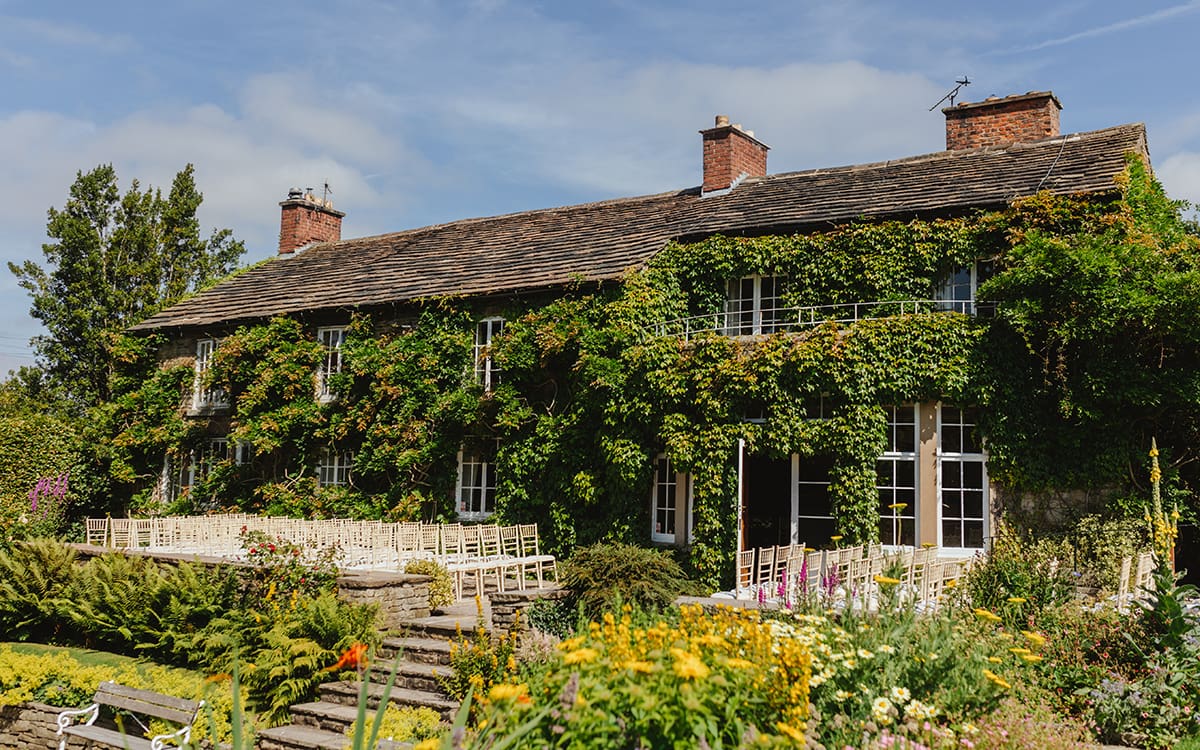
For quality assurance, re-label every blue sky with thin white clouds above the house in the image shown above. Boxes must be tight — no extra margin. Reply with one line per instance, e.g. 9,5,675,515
0,0,1200,372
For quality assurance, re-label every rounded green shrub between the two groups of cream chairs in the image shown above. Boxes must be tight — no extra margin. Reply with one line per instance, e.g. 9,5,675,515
560,544,686,618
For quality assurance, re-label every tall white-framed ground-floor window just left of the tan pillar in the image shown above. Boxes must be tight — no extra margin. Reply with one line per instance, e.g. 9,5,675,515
875,404,918,546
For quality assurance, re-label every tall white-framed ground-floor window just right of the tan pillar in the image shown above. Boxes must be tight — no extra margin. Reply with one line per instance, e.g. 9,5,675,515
937,404,989,550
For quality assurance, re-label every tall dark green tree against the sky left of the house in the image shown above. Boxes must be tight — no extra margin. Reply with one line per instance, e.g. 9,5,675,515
8,164,245,407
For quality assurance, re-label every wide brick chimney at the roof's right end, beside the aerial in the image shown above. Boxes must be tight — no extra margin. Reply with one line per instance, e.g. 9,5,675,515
942,91,1062,151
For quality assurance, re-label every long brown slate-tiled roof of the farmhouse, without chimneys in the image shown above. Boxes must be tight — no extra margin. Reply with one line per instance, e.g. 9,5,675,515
133,124,1147,330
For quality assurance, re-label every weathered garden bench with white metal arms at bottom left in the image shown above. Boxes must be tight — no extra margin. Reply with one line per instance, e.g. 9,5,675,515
58,682,204,750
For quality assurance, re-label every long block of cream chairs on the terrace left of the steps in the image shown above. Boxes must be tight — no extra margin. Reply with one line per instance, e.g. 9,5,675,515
86,514,557,599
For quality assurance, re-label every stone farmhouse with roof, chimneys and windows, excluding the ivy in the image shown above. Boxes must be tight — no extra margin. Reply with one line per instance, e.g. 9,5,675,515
132,91,1148,576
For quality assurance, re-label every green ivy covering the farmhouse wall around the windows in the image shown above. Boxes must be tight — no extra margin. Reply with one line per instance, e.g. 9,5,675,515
100,158,1200,584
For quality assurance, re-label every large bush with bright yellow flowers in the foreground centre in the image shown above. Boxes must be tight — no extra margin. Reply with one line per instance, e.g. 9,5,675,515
480,607,812,748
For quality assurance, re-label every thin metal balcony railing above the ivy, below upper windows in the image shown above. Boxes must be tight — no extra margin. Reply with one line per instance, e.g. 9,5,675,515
650,300,977,341
